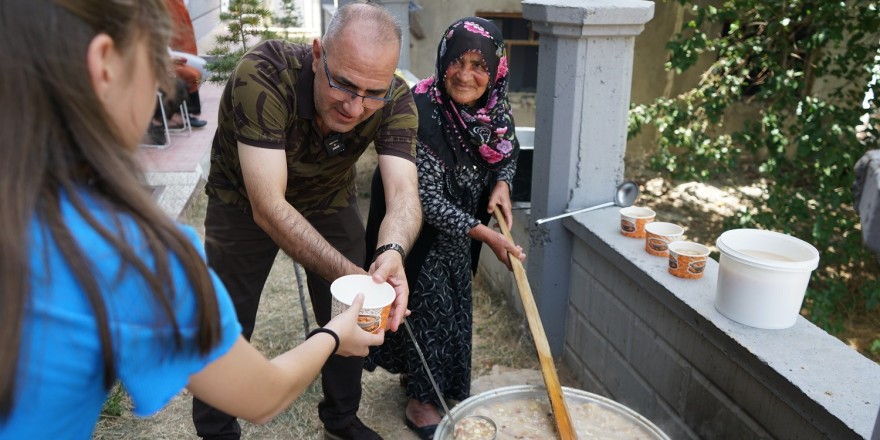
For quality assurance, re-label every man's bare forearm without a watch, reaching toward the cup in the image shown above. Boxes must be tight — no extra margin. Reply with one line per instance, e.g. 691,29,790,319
238,142,364,281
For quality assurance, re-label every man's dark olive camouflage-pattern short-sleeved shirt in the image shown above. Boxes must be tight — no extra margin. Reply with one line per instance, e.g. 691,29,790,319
205,40,418,217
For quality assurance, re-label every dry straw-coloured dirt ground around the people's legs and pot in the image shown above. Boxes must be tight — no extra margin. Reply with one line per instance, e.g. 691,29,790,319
93,149,564,440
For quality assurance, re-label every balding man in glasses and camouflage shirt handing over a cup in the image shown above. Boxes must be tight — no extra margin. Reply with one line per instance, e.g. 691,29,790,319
193,3,421,439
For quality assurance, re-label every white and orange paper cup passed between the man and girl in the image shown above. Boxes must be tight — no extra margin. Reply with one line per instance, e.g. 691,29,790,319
330,275,394,333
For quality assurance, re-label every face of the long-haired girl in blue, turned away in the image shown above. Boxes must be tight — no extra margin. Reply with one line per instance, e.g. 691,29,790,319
103,39,158,148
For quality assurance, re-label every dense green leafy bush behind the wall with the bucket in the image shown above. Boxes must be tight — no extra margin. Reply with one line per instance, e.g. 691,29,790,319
630,0,880,332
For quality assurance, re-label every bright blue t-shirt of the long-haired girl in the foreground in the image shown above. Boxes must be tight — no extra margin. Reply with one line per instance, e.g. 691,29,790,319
0,191,241,440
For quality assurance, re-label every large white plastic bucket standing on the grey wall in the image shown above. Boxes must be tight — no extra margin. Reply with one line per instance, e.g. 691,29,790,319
715,229,819,329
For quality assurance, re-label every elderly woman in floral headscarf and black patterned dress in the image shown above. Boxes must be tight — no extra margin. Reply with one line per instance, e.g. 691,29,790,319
366,17,525,438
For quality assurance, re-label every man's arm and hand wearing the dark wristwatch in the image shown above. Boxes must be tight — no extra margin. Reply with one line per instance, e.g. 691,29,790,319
370,155,422,331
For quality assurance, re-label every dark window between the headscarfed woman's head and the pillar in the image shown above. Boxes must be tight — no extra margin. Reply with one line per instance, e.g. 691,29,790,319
476,12,538,93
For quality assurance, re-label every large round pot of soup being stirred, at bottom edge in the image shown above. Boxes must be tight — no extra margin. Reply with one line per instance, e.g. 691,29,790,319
434,385,669,440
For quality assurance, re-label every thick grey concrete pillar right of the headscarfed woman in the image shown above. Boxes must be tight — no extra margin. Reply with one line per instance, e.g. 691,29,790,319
522,0,654,356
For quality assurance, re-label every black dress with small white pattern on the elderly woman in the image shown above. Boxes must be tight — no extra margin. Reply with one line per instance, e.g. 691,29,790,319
365,140,515,407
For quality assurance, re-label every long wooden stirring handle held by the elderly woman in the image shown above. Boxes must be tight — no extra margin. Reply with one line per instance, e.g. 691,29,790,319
495,211,577,440
